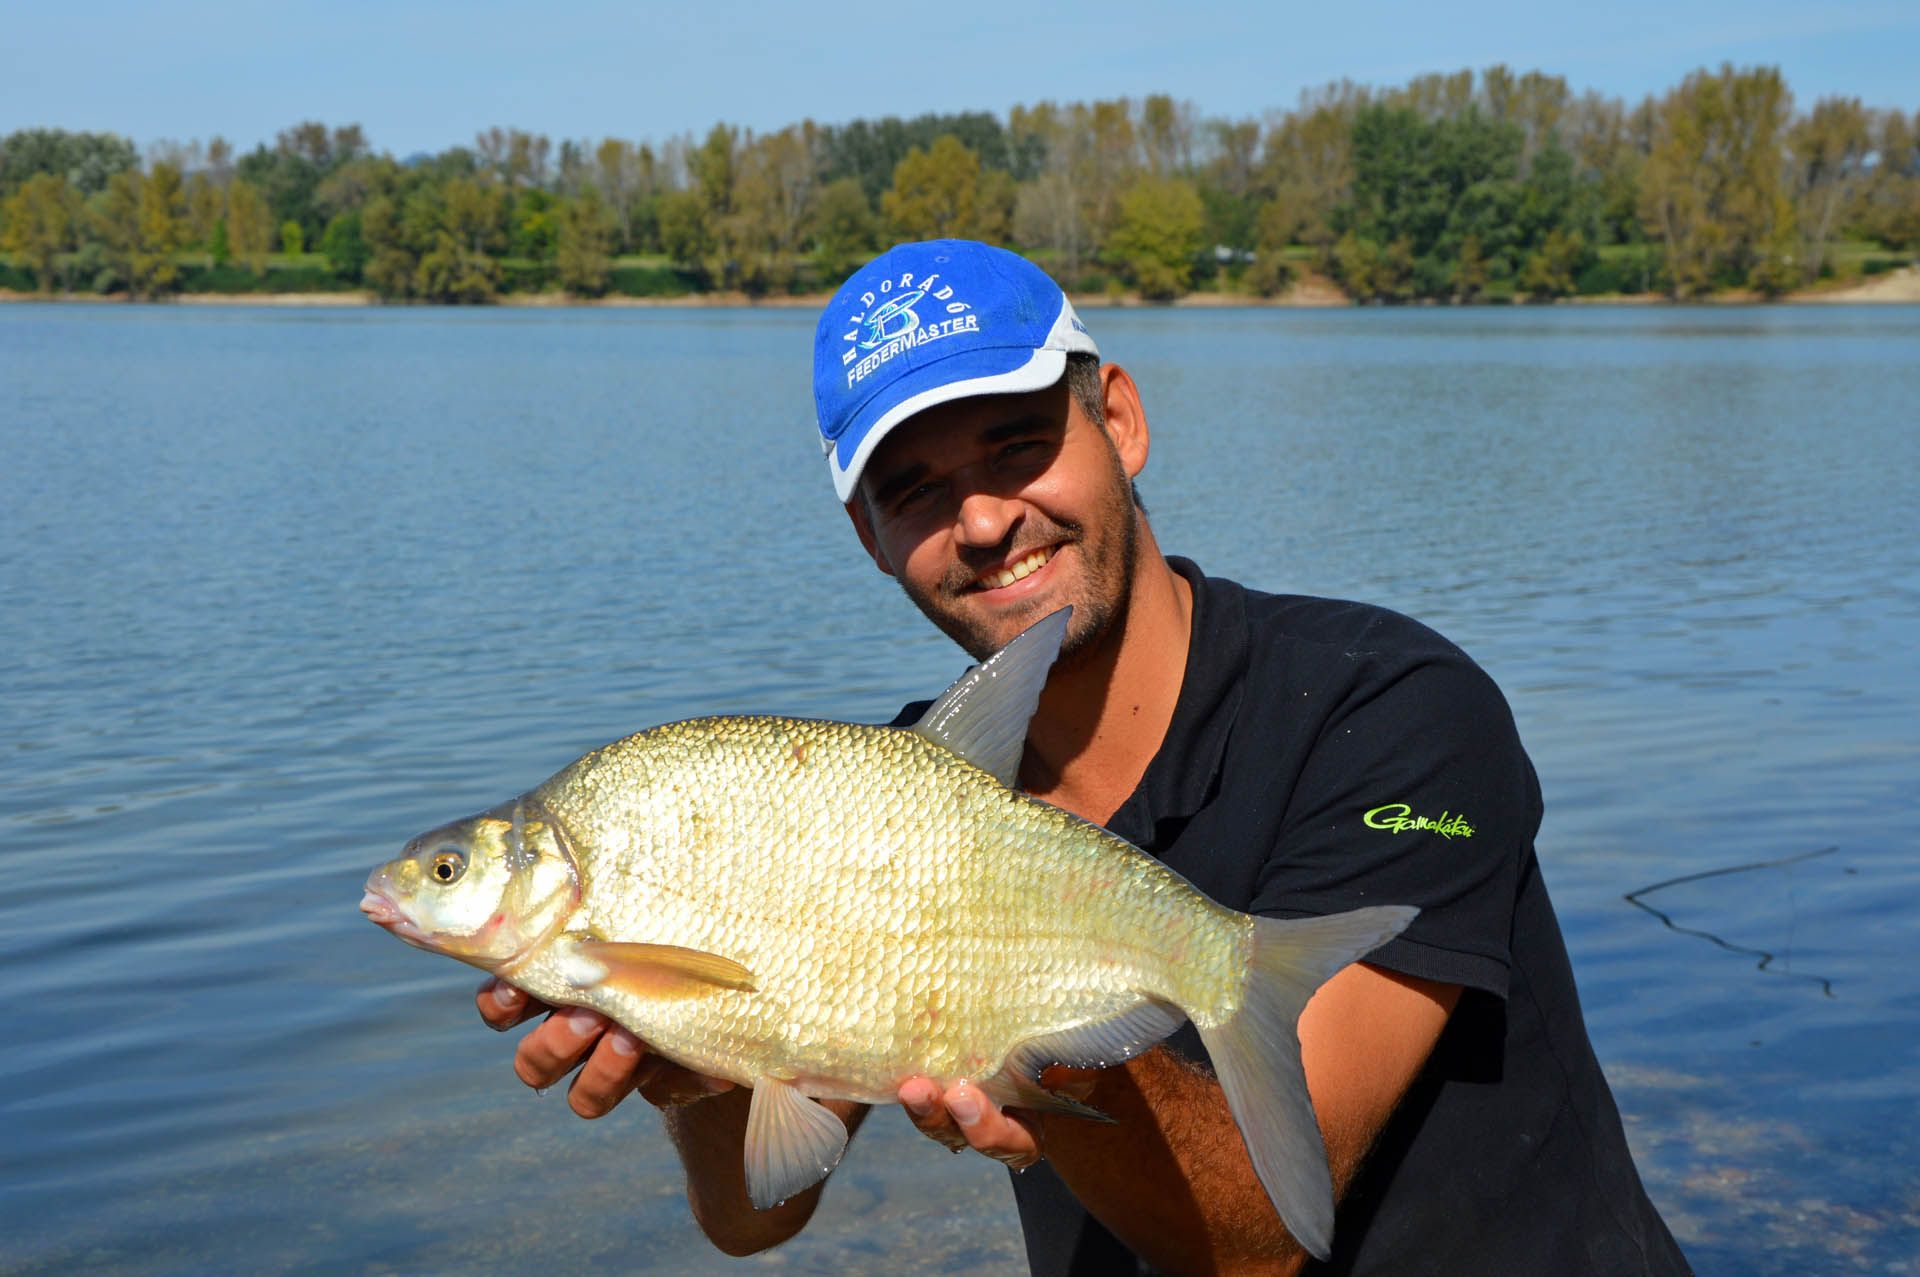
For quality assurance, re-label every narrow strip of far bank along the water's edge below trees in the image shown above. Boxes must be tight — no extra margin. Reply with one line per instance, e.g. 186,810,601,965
0,267,1920,309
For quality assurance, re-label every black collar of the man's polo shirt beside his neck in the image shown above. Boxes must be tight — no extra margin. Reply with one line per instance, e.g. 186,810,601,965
1112,555,1248,847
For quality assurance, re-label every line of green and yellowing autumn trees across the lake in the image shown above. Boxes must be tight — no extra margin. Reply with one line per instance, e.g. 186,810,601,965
0,65,1920,301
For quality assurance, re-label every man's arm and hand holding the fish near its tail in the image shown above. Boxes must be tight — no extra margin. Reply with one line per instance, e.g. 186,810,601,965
900,962,1459,1273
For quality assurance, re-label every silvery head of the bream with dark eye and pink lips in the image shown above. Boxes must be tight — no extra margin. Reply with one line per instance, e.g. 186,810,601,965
361,799,580,974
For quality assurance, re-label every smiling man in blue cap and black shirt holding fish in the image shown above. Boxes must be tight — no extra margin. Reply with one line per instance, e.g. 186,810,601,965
480,240,1686,1273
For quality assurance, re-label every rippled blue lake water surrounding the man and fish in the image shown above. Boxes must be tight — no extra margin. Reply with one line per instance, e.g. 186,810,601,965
0,305,1920,1273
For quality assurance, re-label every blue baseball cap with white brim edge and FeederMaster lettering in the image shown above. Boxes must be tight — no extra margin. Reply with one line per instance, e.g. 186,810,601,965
814,240,1100,503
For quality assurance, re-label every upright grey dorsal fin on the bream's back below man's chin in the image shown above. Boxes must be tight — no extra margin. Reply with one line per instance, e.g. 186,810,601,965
914,607,1073,785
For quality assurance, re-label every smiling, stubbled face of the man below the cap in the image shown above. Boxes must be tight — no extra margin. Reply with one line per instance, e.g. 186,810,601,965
852,380,1144,659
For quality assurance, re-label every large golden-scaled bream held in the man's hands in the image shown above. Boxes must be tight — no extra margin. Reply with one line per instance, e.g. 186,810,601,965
361,611,1415,1256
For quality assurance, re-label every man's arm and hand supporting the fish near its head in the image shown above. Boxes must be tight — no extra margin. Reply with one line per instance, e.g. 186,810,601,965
474,979,866,1256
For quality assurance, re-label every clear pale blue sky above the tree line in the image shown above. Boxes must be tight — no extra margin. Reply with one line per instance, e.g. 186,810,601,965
0,0,1920,156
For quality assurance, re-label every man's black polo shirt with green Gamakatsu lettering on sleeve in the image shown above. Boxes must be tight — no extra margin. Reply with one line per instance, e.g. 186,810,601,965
906,559,1688,1277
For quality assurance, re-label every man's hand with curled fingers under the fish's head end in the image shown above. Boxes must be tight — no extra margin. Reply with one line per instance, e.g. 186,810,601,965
474,977,733,1118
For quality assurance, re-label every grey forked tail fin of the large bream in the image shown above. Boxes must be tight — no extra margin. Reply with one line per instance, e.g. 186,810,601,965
1200,906,1419,1260
